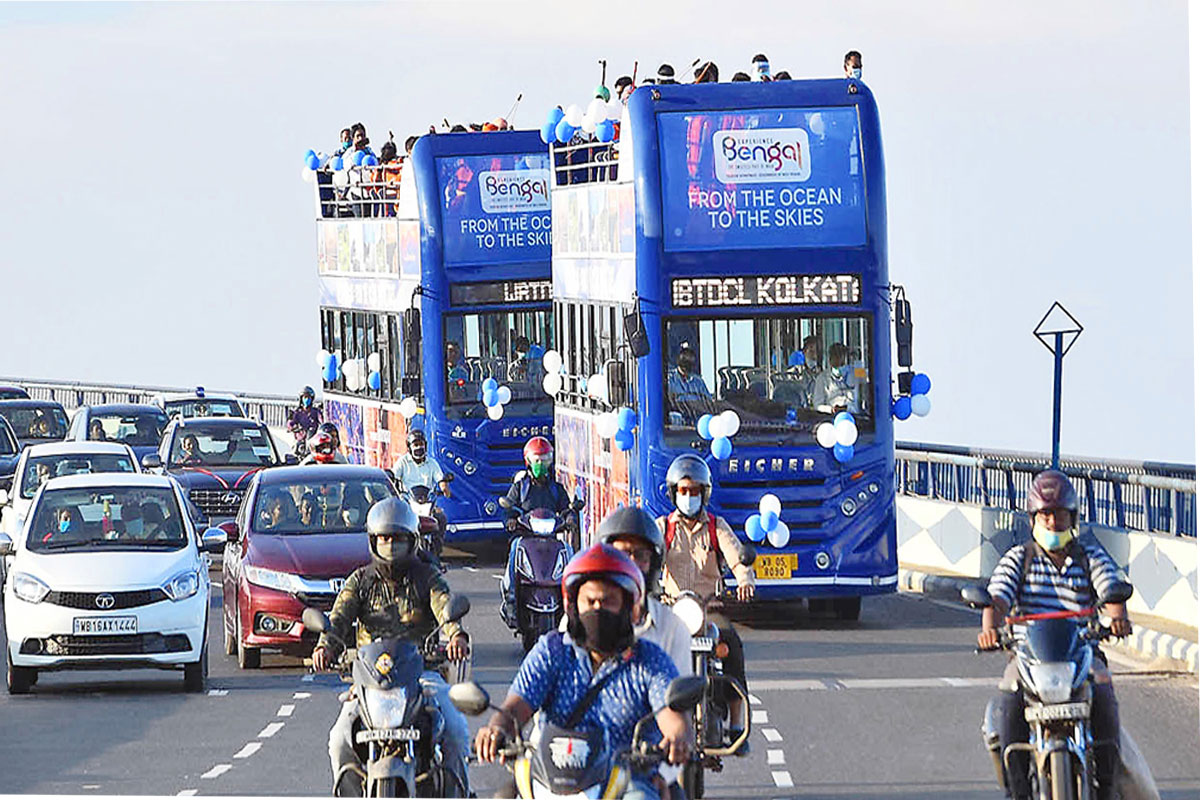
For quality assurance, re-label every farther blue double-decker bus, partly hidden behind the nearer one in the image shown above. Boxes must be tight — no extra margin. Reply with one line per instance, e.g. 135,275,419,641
309,132,553,543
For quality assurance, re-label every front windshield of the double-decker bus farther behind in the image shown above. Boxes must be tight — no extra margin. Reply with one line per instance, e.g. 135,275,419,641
445,308,554,405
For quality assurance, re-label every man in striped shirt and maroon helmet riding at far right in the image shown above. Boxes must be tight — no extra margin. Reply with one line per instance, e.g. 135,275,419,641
978,469,1133,800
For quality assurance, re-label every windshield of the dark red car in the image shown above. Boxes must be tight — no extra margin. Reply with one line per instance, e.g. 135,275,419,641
254,476,396,535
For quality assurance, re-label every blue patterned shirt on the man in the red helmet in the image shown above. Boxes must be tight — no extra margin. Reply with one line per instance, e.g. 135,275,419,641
509,631,679,751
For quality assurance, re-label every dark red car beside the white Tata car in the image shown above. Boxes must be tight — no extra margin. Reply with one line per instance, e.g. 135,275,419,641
222,464,396,669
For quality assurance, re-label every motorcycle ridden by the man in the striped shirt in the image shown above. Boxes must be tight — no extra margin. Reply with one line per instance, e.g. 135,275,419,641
961,583,1133,800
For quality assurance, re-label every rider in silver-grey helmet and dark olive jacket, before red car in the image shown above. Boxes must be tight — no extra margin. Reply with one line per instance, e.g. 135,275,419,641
312,498,470,796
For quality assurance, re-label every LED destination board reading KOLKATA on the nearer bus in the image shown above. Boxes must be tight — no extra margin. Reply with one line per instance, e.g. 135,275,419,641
671,275,863,308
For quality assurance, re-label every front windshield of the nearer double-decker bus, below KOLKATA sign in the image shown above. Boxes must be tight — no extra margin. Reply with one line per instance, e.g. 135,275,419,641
664,314,874,432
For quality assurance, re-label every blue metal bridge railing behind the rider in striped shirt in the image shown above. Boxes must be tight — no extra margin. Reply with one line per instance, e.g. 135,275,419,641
895,441,1196,537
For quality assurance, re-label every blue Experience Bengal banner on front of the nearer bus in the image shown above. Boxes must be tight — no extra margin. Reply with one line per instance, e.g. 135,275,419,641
659,107,866,251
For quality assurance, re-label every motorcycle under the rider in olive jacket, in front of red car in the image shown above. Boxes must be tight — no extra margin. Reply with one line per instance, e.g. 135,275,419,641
301,595,470,798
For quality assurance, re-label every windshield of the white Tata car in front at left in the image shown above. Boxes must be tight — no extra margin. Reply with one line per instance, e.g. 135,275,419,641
28,486,187,553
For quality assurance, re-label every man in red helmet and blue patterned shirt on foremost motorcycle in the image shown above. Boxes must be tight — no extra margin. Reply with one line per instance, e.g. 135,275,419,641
475,543,691,800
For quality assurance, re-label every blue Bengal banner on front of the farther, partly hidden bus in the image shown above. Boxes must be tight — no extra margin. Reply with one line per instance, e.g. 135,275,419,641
437,154,551,265
